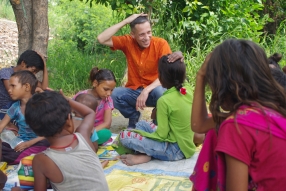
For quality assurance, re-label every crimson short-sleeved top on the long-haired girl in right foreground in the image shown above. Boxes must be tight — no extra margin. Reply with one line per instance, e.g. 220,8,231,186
216,120,286,191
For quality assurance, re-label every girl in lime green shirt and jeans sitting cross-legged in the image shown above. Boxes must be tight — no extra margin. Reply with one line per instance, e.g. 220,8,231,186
119,56,196,166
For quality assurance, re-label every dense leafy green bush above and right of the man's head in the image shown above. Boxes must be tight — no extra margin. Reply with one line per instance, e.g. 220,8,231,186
83,0,286,51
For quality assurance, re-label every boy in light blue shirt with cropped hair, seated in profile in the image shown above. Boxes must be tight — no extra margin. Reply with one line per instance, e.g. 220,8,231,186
0,70,49,164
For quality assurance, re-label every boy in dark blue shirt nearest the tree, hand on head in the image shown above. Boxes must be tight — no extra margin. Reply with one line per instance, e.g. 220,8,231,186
0,50,48,119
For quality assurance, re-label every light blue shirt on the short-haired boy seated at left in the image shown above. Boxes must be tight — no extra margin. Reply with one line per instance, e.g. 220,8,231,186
7,101,37,141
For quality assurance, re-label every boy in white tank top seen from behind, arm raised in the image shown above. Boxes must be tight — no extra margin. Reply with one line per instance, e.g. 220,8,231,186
25,91,109,191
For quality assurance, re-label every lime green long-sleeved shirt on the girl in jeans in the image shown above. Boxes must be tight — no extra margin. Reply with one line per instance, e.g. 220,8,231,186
134,83,196,158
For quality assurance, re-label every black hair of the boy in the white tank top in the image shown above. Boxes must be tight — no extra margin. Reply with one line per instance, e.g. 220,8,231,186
25,91,71,137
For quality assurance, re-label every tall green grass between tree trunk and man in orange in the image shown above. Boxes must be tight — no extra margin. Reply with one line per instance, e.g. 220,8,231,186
47,40,125,95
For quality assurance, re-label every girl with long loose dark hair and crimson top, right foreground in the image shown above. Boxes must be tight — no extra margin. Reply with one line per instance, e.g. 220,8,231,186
192,39,286,191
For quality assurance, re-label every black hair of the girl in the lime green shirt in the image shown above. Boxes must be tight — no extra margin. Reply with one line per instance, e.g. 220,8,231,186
158,55,186,91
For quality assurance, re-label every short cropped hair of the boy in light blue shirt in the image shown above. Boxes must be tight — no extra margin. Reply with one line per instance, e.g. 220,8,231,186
11,70,38,94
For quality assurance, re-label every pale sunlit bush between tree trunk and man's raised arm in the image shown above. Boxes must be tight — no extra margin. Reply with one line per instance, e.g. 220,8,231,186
49,0,115,54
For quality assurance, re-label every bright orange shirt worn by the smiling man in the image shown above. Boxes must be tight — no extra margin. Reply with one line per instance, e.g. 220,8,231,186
111,35,172,90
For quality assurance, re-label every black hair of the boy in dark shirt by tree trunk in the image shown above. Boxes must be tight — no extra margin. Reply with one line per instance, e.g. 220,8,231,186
17,50,44,70
